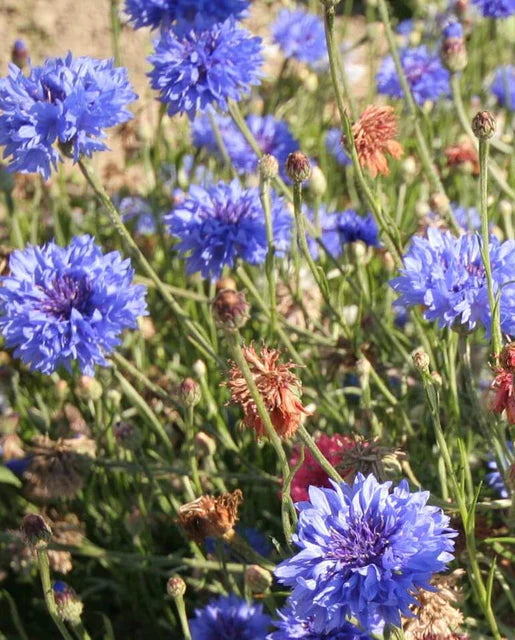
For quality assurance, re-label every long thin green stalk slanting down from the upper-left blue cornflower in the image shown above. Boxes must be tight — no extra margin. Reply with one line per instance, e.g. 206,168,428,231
79,160,223,365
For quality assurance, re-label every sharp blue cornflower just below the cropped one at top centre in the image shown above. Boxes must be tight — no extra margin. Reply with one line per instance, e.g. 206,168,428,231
148,16,263,120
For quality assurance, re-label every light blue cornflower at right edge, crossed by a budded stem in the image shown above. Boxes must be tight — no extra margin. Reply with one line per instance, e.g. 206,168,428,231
390,228,515,334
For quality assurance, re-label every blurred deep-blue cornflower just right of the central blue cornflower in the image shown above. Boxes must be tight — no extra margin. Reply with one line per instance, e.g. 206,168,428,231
308,206,379,260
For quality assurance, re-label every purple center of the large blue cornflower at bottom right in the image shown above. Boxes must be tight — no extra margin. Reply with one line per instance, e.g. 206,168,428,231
328,518,388,568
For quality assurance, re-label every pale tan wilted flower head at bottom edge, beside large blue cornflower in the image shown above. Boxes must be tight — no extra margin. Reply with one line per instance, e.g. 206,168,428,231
403,569,465,640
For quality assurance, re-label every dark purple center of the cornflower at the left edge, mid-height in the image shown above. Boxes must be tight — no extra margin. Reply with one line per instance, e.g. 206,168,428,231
41,276,92,320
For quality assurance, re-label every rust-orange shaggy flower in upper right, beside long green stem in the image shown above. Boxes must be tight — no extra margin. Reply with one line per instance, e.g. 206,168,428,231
352,105,404,178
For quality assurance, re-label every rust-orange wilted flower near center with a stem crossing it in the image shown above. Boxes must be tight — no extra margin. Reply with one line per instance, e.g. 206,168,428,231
228,345,310,438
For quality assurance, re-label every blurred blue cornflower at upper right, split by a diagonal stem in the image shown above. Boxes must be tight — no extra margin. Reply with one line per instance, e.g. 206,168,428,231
377,45,450,105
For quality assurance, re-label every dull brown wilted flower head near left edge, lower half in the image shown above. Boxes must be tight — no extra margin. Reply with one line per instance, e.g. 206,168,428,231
23,435,96,501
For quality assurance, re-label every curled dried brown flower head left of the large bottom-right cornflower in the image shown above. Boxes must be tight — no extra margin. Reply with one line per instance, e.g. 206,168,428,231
178,489,243,542
